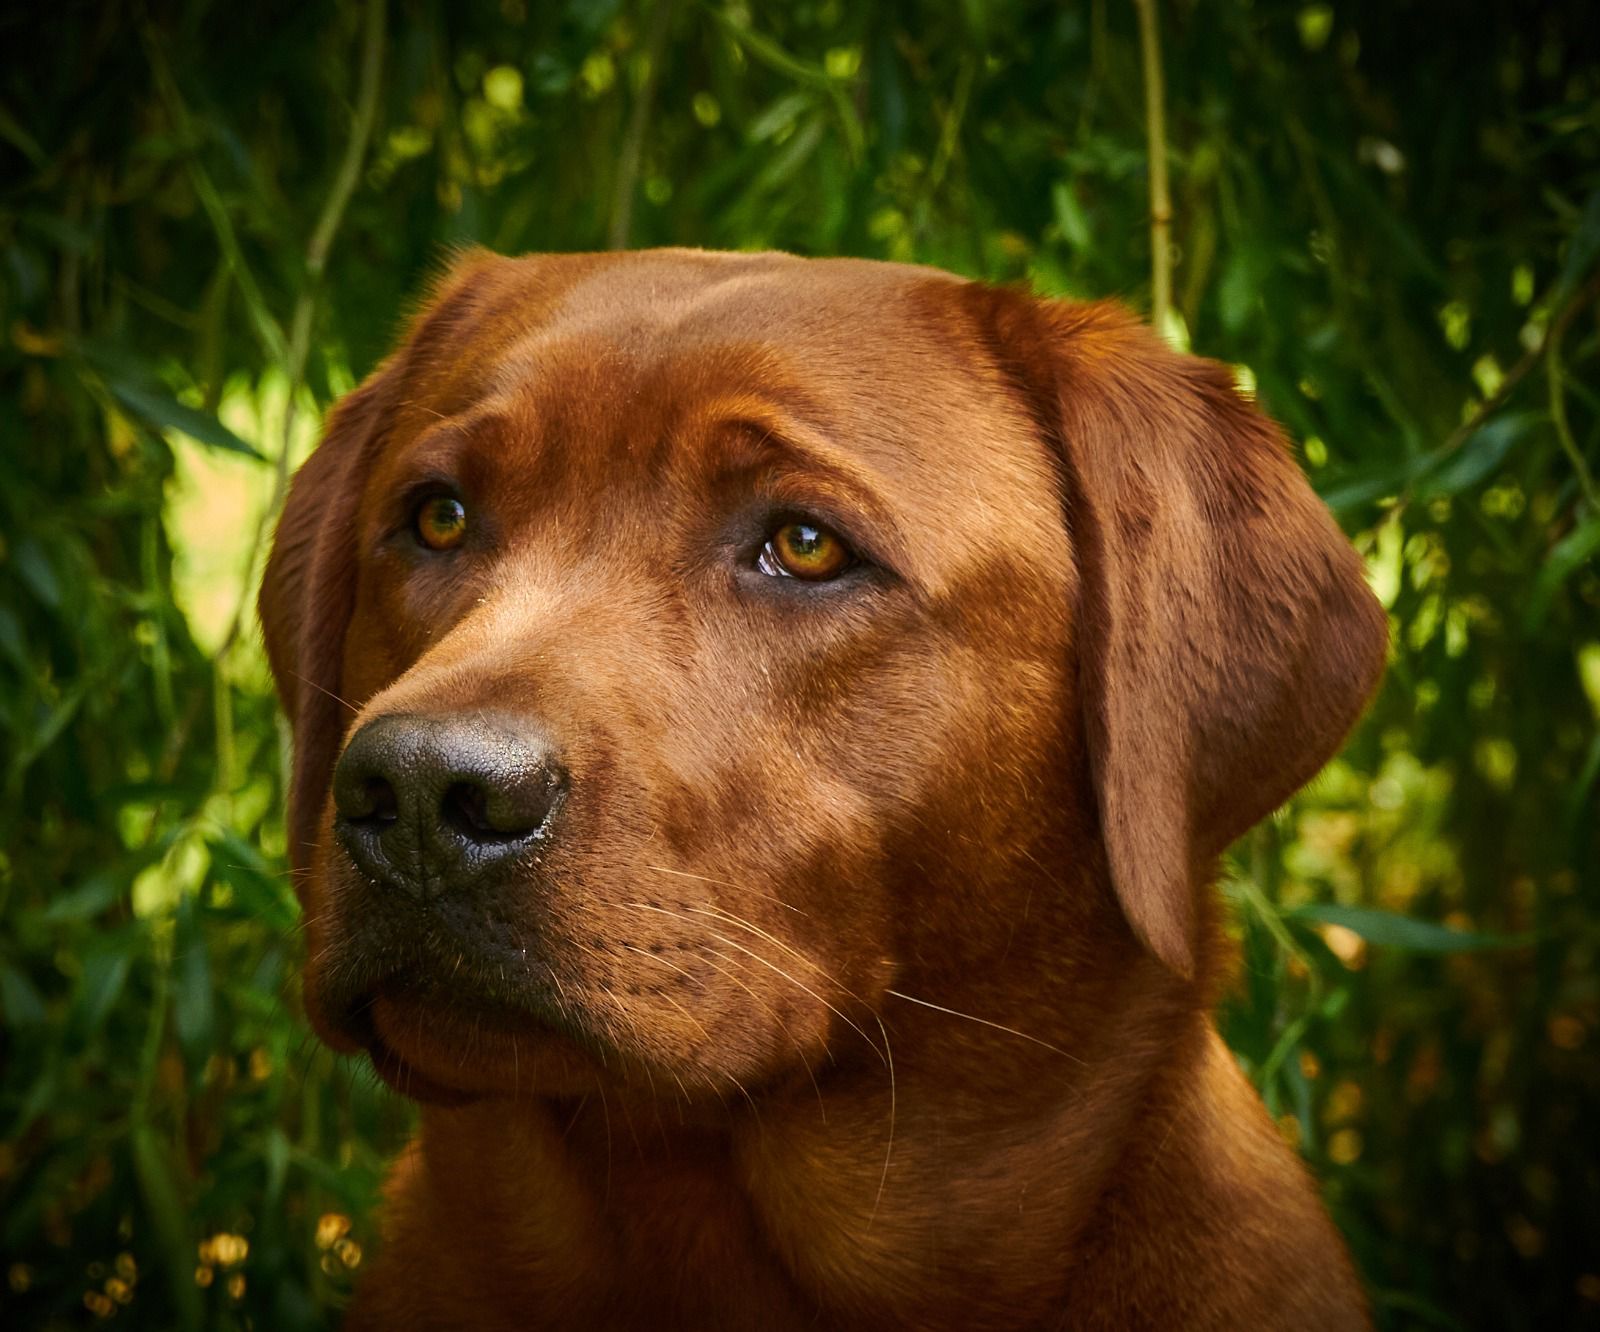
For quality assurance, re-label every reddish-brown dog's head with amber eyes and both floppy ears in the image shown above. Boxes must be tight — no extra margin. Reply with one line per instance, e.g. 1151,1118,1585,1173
261,251,1384,1098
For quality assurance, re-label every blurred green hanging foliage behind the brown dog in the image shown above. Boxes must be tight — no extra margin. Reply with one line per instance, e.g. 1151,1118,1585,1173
0,0,1600,1329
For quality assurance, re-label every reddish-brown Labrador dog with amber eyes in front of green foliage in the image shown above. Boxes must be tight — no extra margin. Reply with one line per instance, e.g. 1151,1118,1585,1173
261,250,1387,1332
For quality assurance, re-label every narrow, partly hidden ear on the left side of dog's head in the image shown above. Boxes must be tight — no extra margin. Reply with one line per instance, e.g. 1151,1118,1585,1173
256,251,498,868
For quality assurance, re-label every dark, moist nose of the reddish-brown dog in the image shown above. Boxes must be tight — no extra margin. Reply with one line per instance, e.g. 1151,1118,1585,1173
333,714,566,898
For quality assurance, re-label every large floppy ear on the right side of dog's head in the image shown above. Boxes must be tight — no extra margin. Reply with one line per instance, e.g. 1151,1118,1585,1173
966,285,1387,977
